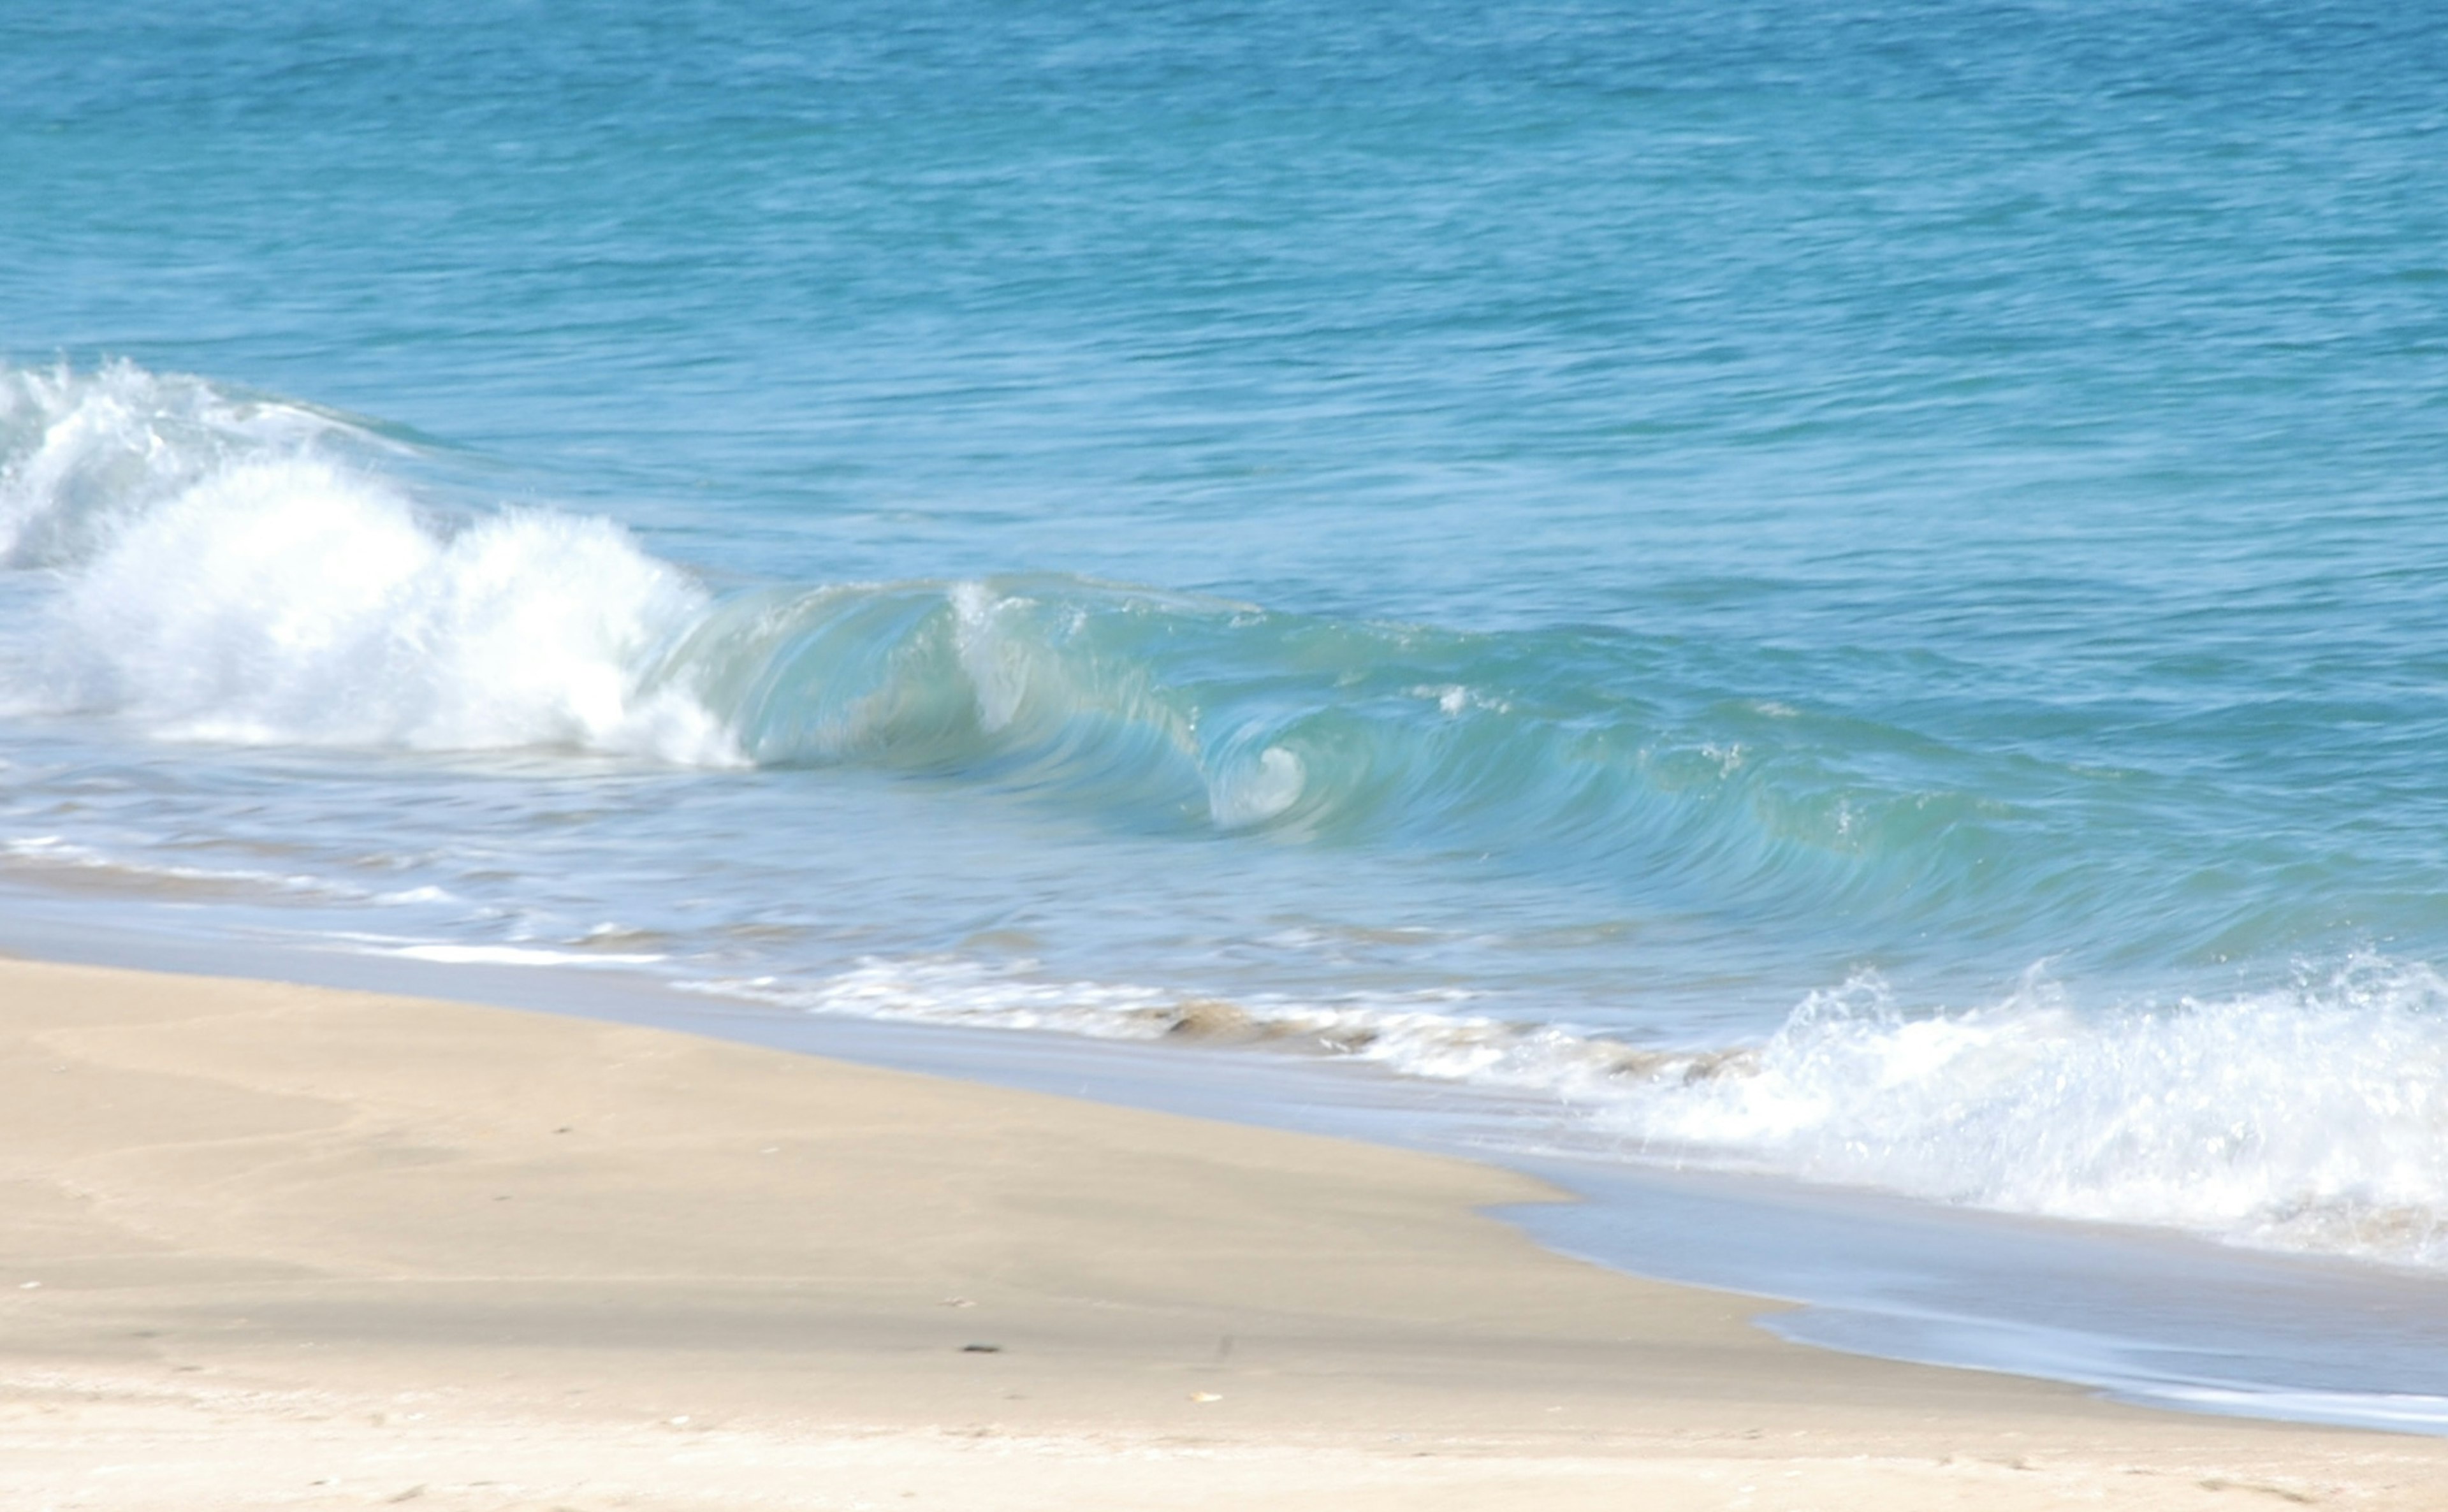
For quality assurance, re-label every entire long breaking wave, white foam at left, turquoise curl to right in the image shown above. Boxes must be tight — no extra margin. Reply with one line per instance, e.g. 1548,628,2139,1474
0,365,2340,983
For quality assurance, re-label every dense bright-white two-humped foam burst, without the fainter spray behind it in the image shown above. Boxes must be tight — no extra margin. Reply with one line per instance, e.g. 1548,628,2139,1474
49,458,734,761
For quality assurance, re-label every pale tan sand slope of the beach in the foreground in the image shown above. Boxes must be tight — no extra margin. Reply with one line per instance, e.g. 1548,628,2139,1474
0,961,2448,1512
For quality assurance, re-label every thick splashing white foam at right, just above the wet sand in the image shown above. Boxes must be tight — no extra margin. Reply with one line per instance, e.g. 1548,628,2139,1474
1601,959,2448,1265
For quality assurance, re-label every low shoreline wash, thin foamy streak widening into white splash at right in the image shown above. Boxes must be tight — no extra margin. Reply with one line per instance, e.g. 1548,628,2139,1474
696,957,2448,1267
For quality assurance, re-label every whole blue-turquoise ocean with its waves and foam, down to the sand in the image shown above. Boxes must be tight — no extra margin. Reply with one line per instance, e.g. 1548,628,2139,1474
0,0,2448,1429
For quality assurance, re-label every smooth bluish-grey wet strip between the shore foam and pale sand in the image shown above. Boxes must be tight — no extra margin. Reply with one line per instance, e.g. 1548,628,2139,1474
19,896,2448,1434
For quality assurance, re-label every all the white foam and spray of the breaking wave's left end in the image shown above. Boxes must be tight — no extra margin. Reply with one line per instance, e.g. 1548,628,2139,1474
0,367,737,764
